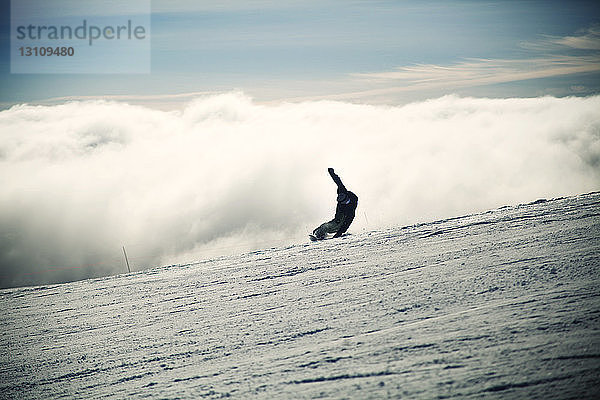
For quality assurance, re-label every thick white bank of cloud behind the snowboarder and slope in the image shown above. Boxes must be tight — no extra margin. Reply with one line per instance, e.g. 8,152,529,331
0,93,600,287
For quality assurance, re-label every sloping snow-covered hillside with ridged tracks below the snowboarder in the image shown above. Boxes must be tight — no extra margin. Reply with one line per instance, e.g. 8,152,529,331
0,193,600,399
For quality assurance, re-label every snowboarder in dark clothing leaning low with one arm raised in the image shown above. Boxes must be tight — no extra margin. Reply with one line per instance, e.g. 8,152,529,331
313,168,358,239
